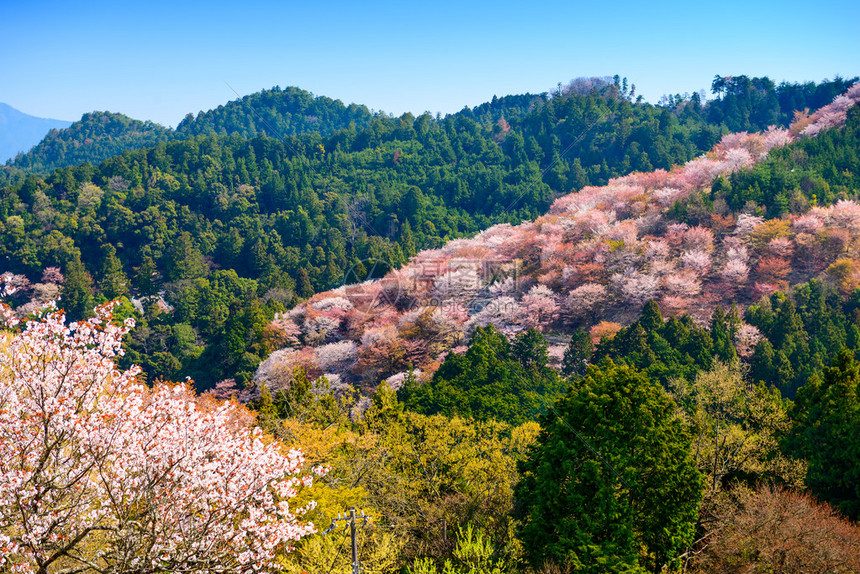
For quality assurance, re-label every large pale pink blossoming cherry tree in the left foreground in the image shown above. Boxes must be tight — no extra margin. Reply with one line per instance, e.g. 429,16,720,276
0,300,325,574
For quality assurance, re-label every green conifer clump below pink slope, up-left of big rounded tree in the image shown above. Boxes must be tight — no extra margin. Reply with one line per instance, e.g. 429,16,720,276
401,325,566,425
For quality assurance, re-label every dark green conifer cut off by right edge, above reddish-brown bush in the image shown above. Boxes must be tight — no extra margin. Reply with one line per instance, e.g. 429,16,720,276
786,349,860,520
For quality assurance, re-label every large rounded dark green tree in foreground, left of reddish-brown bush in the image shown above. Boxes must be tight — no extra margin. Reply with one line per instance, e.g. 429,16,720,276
515,360,702,573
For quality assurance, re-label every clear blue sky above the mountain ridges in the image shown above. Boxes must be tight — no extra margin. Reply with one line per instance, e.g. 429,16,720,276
0,0,860,126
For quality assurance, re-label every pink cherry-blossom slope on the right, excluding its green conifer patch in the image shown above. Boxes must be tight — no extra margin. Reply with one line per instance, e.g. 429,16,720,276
257,85,860,398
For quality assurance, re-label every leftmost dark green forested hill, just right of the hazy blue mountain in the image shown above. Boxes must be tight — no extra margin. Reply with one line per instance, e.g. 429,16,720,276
8,112,173,173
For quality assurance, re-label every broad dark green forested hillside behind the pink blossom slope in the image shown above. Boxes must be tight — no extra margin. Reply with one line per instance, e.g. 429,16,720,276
0,80,808,387
